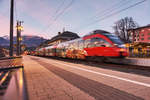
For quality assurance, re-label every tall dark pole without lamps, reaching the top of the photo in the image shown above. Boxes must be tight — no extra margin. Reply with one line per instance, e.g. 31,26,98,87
9,0,14,56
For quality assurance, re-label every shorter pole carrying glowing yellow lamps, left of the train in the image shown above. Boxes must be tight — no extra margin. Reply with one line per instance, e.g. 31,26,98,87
16,21,23,56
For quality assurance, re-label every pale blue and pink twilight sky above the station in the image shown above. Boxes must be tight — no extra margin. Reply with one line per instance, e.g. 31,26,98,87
0,0,150,39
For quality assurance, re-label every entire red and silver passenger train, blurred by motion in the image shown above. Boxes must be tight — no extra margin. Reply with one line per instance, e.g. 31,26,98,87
31,30,128,60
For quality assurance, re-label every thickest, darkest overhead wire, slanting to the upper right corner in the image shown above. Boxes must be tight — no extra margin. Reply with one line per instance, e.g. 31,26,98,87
74,0,147,30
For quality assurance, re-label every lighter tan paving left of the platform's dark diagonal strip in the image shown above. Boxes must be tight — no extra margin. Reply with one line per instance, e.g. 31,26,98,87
23,56,95,100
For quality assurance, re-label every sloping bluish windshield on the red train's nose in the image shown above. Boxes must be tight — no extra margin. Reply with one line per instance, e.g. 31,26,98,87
104,33,124,45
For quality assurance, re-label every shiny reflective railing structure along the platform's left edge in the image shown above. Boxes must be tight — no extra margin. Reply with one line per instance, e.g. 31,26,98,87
0,57,28,100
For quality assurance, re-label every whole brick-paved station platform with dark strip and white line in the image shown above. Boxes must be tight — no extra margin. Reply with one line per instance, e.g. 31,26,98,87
23,56,150,100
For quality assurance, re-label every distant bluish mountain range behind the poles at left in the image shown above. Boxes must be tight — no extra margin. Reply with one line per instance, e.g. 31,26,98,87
0,36,46,47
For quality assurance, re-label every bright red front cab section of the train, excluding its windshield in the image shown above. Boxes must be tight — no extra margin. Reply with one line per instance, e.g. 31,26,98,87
84,34,128,58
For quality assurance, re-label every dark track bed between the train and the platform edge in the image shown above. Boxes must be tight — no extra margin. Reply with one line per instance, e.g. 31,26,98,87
36,57,150,77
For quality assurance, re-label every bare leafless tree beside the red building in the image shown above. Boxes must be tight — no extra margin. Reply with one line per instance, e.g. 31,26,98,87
113,17,139,43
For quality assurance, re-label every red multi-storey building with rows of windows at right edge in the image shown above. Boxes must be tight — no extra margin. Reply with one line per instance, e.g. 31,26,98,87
128,25,150,43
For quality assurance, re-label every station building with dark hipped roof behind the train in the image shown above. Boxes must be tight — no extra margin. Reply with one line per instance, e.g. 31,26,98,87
41,31,80,46
